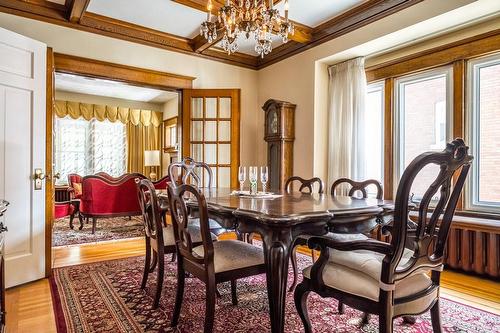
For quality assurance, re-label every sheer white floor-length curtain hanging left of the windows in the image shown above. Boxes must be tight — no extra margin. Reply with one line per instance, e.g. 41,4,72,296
328,58,366,189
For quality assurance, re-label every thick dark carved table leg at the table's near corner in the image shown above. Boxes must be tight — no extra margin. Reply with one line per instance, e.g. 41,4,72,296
263,230,292,333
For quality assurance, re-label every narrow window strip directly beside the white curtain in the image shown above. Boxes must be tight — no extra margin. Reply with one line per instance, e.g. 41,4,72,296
364,82,384,187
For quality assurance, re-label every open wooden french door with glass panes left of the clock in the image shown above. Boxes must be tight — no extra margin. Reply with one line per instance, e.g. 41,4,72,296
182,89,240,188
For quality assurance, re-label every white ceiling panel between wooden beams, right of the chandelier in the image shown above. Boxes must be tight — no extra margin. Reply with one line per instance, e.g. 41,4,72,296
276,0,366,28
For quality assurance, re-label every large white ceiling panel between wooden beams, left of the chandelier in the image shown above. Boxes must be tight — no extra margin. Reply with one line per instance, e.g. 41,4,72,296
87,0,206,38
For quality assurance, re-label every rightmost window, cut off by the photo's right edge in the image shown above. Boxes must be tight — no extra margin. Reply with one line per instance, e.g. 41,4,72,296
466,54,500,212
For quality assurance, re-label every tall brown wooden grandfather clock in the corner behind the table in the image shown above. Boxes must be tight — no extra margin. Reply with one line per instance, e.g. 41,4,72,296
262,99,297,190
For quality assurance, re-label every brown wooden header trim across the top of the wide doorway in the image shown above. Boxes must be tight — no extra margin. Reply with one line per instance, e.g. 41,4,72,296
54,53,195,90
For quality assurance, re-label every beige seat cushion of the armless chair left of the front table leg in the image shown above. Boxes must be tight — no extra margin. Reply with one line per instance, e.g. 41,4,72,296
193,240,264,273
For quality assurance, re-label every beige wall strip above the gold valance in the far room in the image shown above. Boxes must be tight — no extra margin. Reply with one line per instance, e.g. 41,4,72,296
55,90,163,111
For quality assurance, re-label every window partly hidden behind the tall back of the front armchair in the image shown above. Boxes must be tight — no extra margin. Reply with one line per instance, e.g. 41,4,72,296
394,68,452,201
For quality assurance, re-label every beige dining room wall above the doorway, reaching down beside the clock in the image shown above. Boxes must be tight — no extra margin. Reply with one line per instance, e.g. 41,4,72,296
0,13,263,165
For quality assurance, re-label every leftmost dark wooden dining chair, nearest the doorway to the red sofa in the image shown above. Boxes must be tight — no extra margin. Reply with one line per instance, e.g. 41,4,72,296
135,178,212,308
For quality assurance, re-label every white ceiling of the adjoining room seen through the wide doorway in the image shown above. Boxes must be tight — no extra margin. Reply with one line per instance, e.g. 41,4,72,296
55,73,178,103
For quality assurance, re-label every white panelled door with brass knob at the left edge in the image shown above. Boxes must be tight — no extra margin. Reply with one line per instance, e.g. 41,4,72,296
0,28,47,287
